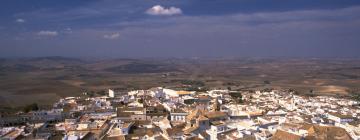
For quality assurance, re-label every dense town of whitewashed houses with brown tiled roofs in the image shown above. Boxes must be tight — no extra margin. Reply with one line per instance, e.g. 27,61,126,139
0,87,360,140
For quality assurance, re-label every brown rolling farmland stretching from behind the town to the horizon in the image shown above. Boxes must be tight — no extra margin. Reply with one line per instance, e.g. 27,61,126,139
0,57,360,107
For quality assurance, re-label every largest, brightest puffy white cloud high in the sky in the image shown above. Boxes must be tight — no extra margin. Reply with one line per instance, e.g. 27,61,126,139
146,5,182,16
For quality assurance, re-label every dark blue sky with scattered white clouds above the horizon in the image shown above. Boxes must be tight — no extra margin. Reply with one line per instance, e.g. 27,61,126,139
0,0,360,58
